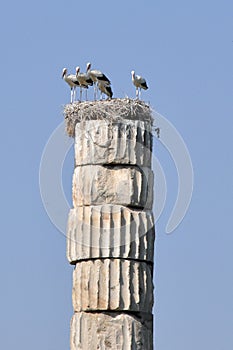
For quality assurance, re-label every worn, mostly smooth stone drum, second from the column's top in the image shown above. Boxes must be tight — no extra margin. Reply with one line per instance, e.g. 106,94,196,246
73,165,154,209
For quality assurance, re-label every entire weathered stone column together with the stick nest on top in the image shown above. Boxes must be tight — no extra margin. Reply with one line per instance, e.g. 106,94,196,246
65,99,155,350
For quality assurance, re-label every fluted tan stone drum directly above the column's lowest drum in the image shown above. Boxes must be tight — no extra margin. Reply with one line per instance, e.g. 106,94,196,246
72,259,153,313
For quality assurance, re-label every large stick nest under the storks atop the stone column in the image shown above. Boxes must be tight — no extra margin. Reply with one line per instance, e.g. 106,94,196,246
64,98,153,137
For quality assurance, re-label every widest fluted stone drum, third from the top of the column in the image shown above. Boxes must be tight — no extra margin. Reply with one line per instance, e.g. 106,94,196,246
67,204,155,263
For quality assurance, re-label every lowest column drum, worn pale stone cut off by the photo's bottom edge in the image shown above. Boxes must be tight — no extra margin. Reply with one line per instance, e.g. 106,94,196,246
70,312,153,350
